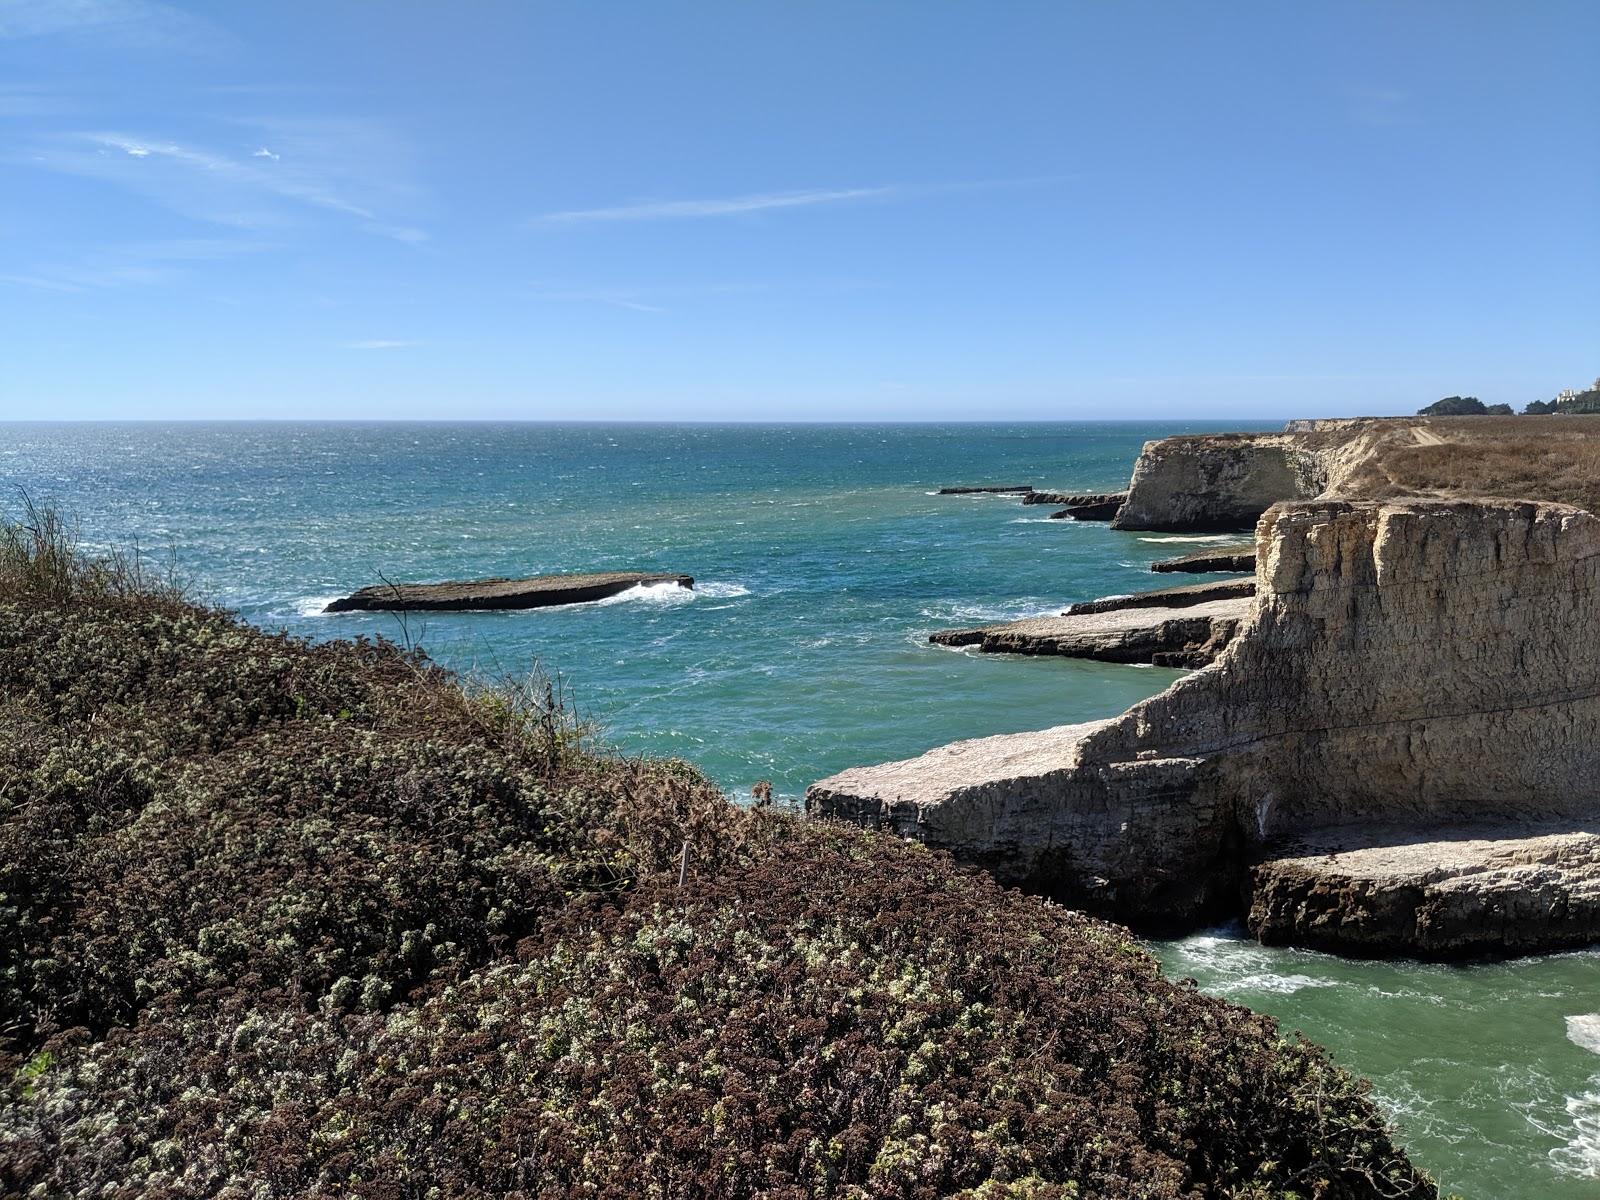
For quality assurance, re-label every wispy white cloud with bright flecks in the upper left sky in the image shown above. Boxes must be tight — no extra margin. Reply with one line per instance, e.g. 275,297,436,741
14,122,427,243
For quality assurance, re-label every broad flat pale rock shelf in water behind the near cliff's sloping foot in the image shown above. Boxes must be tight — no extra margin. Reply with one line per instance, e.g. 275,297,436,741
928,597,1253,667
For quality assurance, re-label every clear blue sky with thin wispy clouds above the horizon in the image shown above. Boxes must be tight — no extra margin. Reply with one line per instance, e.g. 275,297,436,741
0,0,1600,419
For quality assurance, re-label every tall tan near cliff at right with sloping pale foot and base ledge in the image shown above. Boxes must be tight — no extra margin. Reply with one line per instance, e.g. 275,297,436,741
806,499,1600,957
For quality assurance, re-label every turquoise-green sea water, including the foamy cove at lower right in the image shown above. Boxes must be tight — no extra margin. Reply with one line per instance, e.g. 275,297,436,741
0,422,1600,1200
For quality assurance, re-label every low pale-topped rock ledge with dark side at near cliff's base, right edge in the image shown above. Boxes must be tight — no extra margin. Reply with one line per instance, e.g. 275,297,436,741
1250,824,1600,958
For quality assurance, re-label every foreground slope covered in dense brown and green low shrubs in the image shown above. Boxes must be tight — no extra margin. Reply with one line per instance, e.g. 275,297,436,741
0,514,1434,1200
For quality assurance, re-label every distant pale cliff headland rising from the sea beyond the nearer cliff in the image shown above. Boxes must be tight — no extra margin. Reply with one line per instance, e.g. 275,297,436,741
1112,434,1326,531
